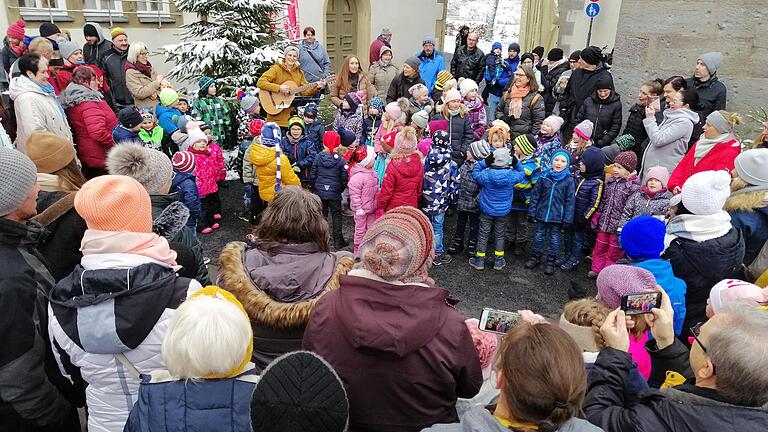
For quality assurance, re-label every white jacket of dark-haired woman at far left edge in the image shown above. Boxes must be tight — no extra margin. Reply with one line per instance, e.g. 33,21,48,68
9,76,72,151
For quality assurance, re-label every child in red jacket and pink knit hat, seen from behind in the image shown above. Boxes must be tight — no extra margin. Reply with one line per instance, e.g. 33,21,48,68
377,126,424,212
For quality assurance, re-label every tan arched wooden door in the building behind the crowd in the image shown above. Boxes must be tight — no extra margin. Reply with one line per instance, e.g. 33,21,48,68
325,0,358,72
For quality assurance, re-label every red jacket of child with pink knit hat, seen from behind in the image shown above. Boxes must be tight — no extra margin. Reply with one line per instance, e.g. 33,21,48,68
378,153,424,211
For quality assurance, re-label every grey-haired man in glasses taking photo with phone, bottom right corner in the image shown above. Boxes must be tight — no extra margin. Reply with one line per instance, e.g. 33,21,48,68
584,288,768,432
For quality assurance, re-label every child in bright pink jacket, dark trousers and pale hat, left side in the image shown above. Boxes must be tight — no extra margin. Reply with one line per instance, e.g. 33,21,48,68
187,125,227,234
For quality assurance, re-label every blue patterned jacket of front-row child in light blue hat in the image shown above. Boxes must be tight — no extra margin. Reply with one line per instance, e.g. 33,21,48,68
528,172,576,224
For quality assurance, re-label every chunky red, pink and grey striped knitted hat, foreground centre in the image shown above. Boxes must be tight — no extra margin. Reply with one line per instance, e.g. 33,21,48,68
358,206,434,282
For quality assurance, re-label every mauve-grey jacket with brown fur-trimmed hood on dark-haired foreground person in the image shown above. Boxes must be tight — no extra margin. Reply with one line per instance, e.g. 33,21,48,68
219,242,354,372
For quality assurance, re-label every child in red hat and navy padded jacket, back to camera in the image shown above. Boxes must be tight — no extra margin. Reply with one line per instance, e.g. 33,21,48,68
309,131,349,250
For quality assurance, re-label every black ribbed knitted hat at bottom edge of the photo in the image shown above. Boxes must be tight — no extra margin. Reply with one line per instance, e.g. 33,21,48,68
251,351,349,432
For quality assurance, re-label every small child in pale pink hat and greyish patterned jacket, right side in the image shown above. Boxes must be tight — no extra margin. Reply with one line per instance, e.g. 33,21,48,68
619,165,672,229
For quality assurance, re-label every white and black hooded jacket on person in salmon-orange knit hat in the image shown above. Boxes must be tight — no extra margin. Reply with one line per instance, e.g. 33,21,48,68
48,254,202,432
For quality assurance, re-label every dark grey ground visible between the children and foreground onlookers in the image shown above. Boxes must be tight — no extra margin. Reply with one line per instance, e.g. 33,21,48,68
201,181,596,318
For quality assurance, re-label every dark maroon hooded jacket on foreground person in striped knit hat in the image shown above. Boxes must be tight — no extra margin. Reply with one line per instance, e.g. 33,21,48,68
302,270,483,432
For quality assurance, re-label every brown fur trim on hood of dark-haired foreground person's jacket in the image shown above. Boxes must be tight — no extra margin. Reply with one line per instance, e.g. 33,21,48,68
219,242,354,329
